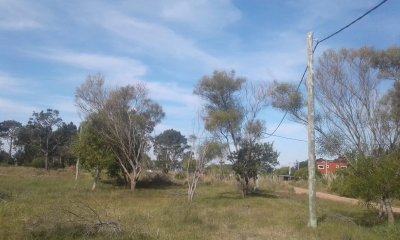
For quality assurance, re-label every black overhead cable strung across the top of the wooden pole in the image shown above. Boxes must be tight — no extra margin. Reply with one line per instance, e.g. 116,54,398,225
265,0,388,141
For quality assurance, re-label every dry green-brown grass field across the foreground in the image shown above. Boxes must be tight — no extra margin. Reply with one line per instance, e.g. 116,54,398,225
0,167,400,240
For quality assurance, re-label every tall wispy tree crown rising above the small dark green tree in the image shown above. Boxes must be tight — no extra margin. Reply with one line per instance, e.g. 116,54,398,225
194,71,276,193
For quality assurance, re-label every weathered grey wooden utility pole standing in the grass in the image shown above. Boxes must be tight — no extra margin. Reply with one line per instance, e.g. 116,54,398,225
307,32,317,228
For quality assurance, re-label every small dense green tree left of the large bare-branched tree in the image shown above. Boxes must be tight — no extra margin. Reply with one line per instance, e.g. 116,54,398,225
71,121,115,190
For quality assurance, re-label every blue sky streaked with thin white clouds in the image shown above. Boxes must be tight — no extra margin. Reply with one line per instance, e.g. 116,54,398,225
0,0,400,165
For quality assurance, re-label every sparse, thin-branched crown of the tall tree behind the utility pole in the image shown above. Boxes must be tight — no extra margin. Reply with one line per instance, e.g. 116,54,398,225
270,48,400,156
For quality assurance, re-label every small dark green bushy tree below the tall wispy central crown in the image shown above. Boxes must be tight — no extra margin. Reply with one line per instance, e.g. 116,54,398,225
229,143,279,197
